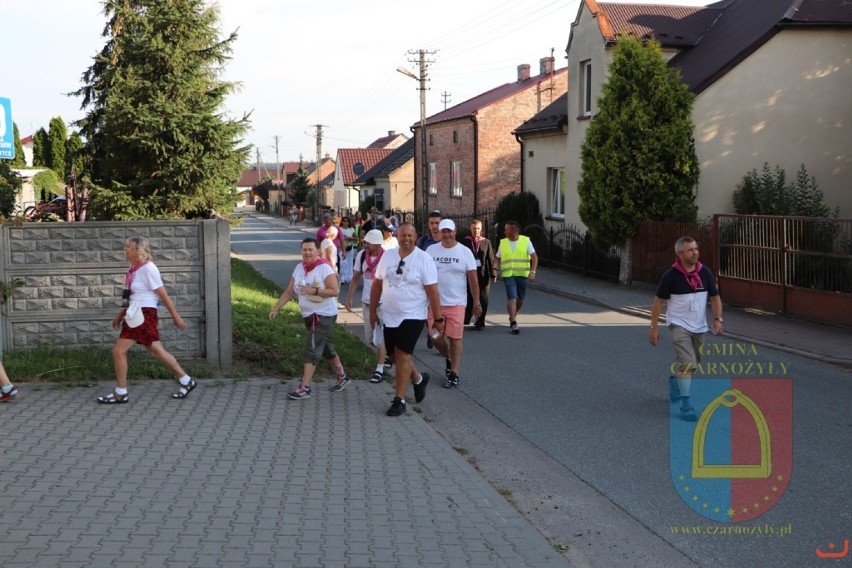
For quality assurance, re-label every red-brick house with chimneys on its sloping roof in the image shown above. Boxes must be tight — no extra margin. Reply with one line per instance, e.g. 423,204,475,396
412,57,568,215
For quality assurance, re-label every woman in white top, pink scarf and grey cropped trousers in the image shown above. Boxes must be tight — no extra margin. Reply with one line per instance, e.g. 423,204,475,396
269,238,349,400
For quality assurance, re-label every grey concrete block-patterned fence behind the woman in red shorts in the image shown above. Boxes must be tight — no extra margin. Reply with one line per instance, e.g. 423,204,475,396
0,220,233,367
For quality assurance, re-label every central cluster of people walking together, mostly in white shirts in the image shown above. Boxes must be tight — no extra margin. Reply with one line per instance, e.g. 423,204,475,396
269,206,538,416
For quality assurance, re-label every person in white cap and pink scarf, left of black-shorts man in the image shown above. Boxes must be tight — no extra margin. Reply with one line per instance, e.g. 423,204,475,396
346,229,386,383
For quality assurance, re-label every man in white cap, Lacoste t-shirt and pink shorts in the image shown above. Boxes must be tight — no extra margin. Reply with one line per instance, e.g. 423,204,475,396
426,219,482,389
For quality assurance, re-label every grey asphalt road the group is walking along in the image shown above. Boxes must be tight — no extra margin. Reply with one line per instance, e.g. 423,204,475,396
232,214,852,567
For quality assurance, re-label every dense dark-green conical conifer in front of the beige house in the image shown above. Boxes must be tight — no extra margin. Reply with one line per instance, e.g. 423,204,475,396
577,36,699,250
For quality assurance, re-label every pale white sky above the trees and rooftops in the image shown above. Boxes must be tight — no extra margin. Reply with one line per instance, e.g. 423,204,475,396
0,0,709,168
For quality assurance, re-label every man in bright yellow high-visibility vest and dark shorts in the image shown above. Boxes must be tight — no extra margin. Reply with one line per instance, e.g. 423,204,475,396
495,221,538,335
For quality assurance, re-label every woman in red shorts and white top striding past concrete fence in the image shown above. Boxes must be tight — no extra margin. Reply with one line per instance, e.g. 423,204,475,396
98,236,198,404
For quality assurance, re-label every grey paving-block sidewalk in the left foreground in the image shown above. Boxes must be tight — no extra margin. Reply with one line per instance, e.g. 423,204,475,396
0,379,569,568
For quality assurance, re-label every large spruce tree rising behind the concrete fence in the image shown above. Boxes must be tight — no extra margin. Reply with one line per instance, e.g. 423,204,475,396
75,0,248,219
